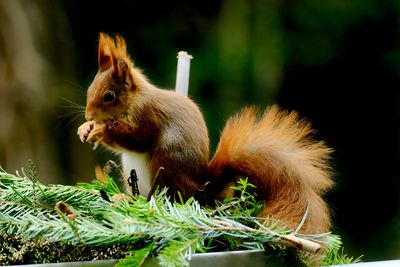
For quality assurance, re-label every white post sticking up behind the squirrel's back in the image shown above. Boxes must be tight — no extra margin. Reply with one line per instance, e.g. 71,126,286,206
175,51,193,96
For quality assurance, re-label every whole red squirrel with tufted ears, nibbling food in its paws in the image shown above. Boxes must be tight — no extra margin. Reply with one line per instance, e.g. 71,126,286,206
78,33,333,237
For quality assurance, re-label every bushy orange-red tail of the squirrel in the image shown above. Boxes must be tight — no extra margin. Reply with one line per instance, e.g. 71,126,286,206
208,106,333,236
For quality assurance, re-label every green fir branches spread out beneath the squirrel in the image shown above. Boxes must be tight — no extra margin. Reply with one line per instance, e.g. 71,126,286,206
0,167,360,266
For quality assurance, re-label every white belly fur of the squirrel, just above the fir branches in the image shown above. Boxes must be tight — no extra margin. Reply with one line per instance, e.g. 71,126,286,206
121,152,151,197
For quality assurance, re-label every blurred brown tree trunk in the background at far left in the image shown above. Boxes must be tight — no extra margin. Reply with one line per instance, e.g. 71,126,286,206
0,0,90,182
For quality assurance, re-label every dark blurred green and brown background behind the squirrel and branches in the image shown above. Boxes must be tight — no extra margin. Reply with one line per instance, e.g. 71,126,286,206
0,0,400,261
